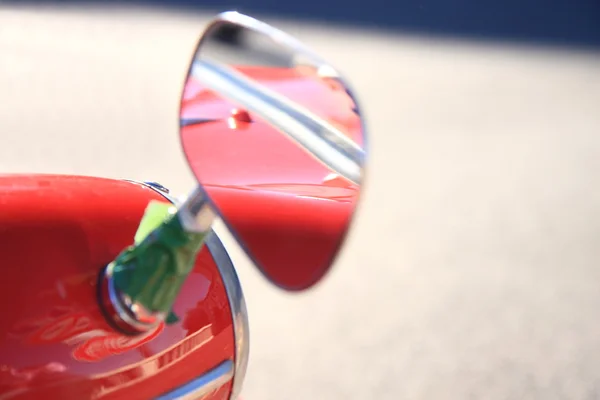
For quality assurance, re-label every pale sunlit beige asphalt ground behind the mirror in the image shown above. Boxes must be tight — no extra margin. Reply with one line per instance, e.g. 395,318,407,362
0,3,600,400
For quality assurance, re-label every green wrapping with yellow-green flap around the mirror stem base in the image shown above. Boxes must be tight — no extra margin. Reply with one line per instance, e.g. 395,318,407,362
113,201,207,324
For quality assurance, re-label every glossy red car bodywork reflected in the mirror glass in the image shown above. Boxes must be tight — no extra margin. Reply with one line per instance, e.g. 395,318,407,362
181,67,363,290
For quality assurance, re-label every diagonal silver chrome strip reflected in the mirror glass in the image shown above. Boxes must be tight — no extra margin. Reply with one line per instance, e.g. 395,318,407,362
192,60,364,185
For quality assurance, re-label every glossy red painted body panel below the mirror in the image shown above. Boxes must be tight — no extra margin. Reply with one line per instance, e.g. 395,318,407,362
0,175,235,400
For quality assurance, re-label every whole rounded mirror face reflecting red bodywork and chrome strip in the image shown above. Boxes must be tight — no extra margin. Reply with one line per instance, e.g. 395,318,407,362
180,13,365,290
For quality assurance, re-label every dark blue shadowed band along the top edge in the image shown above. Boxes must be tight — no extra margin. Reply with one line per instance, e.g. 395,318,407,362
7,0,600,48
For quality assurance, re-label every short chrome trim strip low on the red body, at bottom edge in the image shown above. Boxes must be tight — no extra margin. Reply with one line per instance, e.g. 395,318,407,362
157,360,233,400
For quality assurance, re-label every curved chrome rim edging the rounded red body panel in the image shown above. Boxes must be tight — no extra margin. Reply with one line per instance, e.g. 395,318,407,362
127,180,250,399
